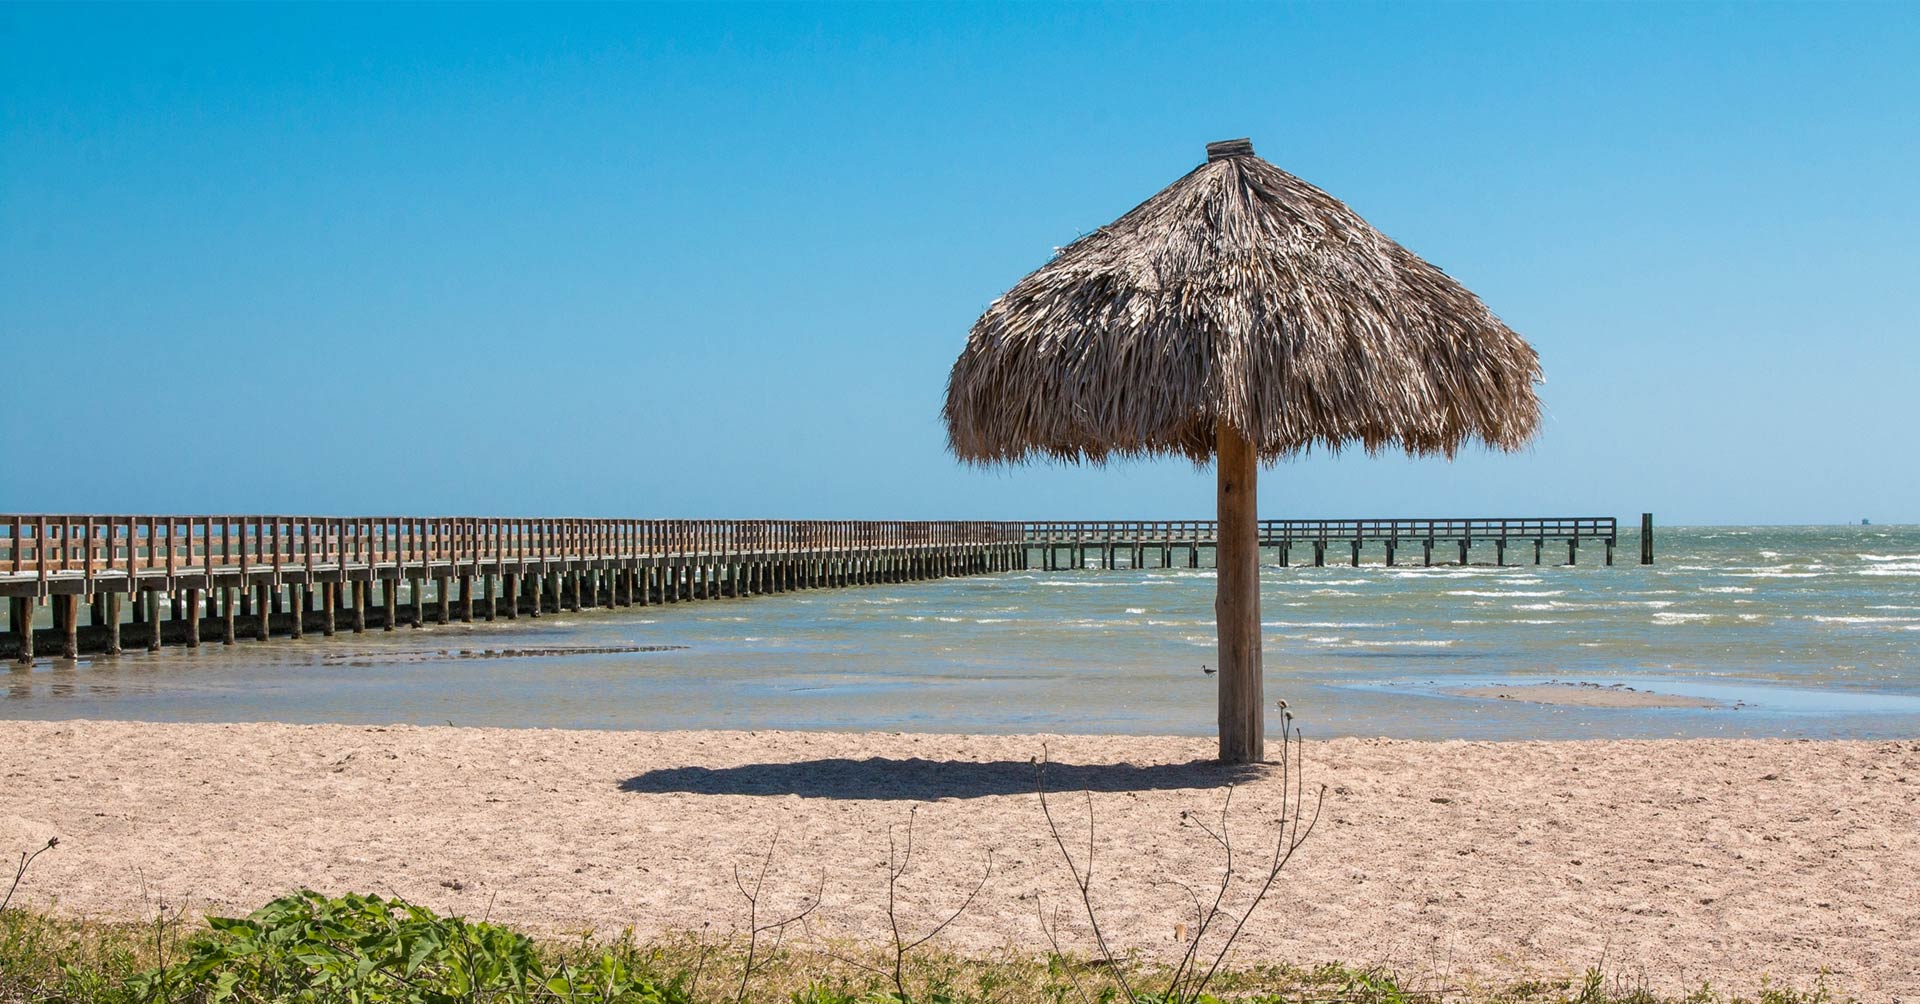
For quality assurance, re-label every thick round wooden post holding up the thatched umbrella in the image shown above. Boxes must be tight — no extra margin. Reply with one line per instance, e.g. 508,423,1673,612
1194,422,1265,764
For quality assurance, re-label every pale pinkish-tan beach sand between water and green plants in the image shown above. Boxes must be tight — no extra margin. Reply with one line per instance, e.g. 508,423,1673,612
0,722,1920,1000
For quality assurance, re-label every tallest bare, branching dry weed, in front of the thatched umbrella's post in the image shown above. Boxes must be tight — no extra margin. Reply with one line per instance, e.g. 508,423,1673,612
1035,714,1327,1004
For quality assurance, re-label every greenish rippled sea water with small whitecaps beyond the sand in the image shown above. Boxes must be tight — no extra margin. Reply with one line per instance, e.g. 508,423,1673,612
0,526,1920,739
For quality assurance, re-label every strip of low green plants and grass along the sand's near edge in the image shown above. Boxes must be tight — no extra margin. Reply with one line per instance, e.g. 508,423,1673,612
0,893,1847,1004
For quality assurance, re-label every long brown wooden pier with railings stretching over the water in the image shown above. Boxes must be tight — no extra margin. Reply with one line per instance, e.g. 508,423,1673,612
0,514,1653,662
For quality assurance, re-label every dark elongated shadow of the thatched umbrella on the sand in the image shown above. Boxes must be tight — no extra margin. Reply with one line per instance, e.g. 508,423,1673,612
620,756,1265,801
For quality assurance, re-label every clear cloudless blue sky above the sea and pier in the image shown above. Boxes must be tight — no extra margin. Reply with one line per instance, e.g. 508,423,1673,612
0,4,1920,522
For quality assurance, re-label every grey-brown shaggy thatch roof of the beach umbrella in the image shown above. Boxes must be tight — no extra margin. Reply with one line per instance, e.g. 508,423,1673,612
945,140,1540,463
